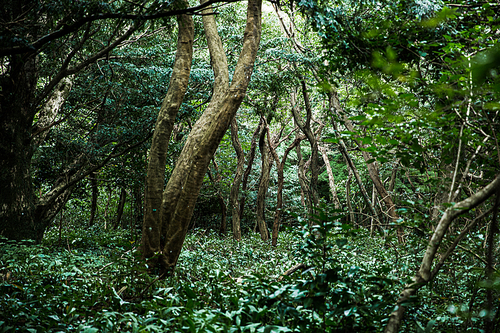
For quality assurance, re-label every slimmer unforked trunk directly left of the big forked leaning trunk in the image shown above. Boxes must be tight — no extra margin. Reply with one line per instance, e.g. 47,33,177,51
141,3,194,260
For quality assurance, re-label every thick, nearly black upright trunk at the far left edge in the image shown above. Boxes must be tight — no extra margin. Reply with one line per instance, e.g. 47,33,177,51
0,0,38,240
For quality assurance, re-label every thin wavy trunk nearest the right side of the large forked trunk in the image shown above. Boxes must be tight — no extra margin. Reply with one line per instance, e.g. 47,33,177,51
229,118,245,241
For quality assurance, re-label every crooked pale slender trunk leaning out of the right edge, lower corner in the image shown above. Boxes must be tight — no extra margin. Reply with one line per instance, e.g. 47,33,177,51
384,175,500,333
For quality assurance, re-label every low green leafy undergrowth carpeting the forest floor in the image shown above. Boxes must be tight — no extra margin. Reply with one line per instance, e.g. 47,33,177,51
0,212,492,332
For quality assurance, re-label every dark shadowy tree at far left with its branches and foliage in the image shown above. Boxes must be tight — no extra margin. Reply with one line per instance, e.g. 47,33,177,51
0,0,246,240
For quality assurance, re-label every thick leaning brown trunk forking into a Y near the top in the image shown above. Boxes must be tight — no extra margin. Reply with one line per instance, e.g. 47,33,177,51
143,0,262,276
